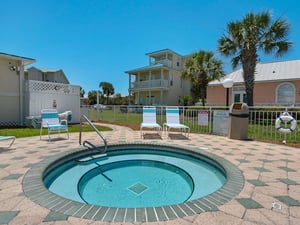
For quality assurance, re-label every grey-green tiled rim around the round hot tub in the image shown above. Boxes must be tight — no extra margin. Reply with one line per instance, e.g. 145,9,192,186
23,142,244,222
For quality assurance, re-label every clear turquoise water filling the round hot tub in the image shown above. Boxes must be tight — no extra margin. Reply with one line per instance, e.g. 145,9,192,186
44,149,226,208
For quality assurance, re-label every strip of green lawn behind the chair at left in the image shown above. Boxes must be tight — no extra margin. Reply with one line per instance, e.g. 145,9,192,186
0,124,111,138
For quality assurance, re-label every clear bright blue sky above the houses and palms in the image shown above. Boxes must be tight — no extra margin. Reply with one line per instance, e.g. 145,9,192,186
0,0,300,95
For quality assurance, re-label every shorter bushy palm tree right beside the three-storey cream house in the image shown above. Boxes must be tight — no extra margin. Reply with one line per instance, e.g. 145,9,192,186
182,50,223,106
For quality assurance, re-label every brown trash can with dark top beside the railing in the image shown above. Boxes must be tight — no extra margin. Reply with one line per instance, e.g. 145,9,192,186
228,103,249,140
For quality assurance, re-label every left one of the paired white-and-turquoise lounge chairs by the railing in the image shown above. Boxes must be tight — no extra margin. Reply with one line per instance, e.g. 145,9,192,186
140,106,161,138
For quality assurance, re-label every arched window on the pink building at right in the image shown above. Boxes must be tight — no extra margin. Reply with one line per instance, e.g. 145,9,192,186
276,83,295,104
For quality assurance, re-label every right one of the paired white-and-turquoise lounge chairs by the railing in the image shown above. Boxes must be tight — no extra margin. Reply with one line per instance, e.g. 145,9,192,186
163,107,190,137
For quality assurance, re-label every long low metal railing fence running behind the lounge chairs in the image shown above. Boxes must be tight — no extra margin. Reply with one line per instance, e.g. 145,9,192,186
88,105,300,143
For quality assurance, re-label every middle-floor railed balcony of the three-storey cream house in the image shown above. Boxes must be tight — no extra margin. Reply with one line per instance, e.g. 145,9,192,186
130,79,169,90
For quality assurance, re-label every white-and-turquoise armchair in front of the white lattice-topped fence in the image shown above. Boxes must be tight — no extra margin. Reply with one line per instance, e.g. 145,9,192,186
40,109,69,141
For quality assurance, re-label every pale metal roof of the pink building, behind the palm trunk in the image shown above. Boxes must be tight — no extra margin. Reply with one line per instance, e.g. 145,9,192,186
209,60,300,86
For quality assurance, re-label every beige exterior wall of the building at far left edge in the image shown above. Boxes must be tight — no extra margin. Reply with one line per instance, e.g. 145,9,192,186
0,59,20,126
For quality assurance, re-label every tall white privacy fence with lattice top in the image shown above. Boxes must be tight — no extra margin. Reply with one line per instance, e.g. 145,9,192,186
25,80,80,123
